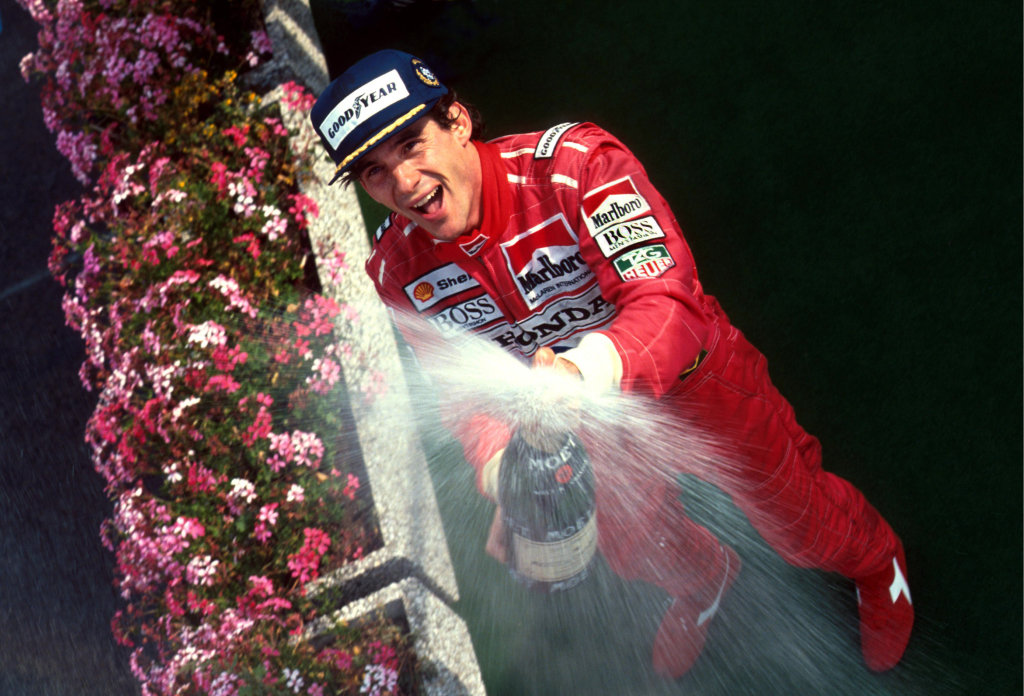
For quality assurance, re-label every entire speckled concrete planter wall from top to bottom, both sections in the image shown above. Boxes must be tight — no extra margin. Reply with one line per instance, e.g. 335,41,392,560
249,0,485,696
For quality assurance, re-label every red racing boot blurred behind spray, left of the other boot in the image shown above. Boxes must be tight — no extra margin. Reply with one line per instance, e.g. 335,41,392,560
651,547,742,679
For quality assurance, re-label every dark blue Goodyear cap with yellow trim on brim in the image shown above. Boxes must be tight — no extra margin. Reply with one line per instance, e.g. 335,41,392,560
309,50,447,183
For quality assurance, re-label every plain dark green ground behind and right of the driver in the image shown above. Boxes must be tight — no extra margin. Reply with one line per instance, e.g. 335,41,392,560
313,0,1022,694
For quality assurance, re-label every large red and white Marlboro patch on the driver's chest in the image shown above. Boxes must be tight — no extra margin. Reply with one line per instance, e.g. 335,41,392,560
502,213,594,309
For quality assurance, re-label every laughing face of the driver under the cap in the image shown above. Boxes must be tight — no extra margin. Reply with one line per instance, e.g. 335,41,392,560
354,102,482,242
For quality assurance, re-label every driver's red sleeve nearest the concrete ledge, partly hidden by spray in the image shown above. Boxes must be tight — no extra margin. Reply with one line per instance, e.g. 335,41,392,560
366,244,512,494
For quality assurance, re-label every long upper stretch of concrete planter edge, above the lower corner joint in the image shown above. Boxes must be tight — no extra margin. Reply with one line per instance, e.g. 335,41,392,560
258,0,459,618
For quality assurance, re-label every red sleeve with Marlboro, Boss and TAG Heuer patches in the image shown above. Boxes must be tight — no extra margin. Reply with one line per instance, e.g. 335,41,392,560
573,134,710,397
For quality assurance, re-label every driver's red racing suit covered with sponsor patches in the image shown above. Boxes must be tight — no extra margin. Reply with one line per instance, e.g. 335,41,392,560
367,124,897,597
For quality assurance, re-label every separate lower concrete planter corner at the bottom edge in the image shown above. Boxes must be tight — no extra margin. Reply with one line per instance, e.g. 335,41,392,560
303,578,486,696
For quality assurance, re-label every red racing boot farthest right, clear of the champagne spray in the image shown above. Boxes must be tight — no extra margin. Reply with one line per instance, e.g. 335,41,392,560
857,543,913,671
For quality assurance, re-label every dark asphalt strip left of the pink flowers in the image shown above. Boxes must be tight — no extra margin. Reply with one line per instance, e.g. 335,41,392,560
0,0,138,696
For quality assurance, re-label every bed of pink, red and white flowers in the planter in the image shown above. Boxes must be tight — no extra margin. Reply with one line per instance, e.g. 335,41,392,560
22,0,416,696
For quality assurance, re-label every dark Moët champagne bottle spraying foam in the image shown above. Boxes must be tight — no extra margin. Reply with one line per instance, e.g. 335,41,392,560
498,428,597,593
